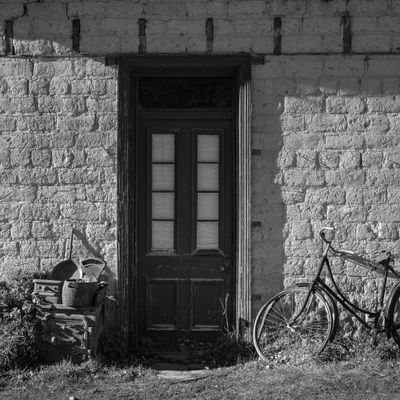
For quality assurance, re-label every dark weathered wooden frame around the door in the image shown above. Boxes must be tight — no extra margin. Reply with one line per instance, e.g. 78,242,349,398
117,55,251,349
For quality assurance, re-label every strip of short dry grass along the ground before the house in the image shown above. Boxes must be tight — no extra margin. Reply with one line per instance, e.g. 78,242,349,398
0,341,400,400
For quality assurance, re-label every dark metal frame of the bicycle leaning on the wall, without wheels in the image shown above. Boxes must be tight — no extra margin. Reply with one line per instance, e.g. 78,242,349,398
292,242,400,332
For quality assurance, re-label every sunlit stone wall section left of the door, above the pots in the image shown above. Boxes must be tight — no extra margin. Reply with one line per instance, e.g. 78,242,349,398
0,57,117,282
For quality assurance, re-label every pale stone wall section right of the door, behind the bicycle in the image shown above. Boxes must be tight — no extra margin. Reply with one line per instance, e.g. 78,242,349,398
252,55,400,324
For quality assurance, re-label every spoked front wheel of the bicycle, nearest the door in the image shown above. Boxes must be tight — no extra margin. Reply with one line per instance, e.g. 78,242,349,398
253,286,334,362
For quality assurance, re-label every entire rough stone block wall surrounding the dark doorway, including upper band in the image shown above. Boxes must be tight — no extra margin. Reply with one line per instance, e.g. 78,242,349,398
0,0,400,334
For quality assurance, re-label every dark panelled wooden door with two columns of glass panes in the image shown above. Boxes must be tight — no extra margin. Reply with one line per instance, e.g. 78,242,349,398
136,109,235,336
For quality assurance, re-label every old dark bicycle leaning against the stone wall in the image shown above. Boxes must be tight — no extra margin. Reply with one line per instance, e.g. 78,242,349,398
253,227,400,361
